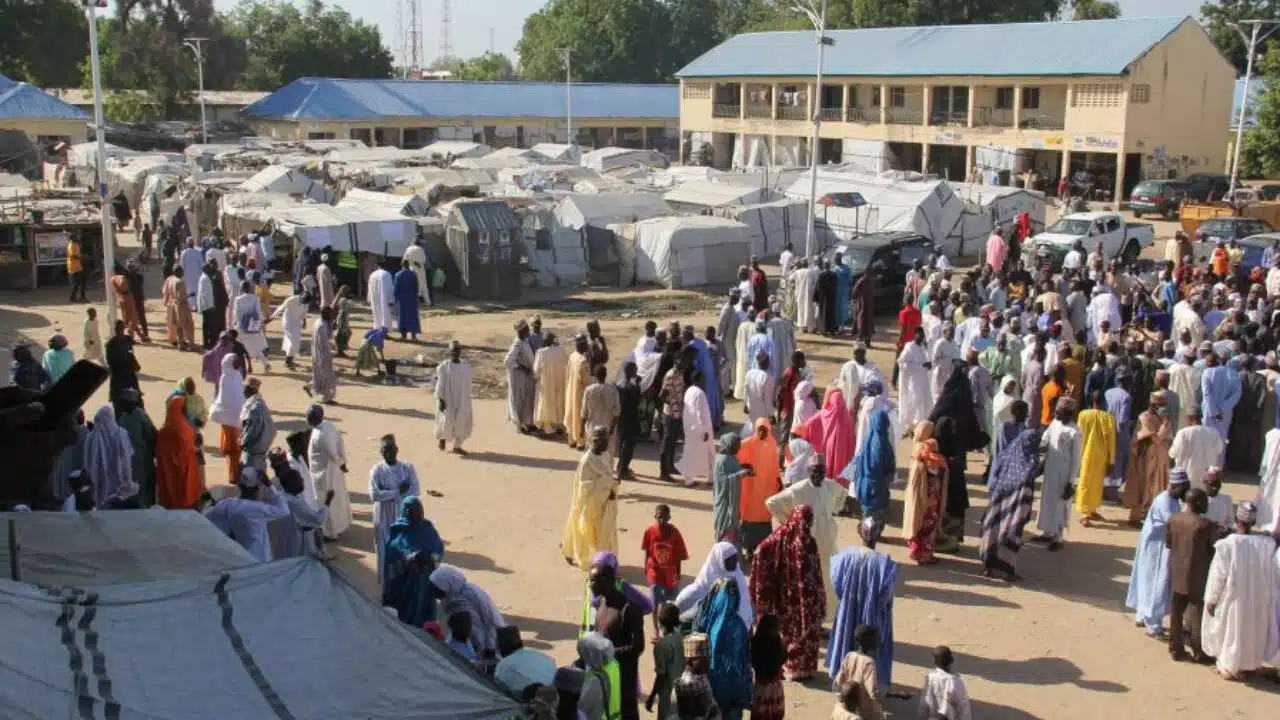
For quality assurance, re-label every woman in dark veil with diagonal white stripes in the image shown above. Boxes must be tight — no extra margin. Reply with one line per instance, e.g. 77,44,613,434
978,430,1039,582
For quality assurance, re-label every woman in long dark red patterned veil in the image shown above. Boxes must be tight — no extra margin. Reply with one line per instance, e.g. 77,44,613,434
751,505,827,680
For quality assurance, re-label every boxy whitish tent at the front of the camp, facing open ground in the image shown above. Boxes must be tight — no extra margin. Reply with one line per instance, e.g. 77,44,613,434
611,215,751,288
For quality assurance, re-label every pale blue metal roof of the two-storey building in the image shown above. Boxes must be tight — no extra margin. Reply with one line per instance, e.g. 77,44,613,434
677,17,1194,77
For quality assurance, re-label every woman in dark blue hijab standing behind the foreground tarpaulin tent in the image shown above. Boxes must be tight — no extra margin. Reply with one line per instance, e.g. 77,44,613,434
383,495,444,628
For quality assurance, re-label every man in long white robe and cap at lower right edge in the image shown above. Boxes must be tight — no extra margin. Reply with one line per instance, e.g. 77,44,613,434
1201,502,1280,680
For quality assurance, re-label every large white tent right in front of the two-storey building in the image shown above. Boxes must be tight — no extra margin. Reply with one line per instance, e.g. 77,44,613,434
785,170,973,255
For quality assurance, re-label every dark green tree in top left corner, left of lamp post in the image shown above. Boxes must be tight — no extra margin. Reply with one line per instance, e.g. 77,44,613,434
0,0,88,87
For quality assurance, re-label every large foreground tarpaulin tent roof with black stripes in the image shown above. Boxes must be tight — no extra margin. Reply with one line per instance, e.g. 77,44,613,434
0,561,526,720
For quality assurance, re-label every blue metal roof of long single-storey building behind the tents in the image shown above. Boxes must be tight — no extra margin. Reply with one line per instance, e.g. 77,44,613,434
244,78,680,122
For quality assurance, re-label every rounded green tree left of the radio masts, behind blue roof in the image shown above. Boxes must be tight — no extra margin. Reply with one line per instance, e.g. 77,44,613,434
228,0,393,90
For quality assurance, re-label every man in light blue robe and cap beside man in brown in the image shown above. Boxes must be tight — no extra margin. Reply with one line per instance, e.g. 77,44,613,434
1125,470,1190,638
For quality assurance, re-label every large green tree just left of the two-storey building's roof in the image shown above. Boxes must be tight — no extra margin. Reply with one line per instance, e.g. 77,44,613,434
516,0,677,82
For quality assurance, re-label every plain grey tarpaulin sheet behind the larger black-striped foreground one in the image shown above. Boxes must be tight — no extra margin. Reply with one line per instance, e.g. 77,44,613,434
0,509,255,586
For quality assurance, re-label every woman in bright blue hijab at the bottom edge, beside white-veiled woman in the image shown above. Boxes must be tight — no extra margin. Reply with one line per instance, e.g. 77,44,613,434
694,579,751,720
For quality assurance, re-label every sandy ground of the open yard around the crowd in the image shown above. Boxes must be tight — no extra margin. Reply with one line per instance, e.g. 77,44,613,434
0,215,1280,720
